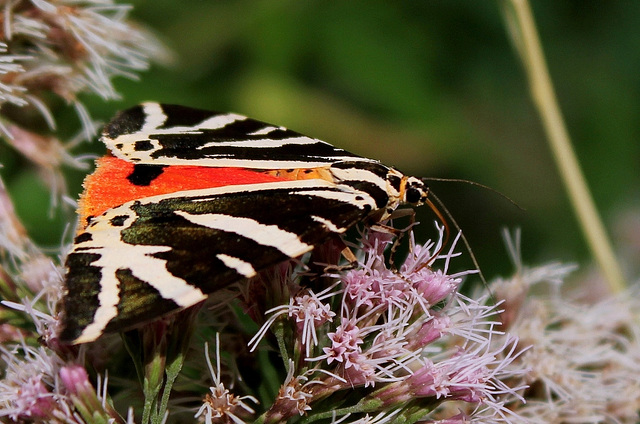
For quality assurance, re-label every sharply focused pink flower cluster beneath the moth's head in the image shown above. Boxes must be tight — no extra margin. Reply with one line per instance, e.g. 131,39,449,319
238,231,522,422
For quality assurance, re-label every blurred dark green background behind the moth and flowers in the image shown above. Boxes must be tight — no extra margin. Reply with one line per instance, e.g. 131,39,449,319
0,0,640,277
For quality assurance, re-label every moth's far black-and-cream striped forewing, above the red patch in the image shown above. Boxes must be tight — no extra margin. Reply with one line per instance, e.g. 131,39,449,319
102,103,377,169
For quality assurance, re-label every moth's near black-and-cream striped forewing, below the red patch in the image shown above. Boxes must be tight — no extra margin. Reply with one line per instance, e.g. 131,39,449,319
60,180,376,343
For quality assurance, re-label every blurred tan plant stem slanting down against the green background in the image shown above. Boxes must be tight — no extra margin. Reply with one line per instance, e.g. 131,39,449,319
503,0,626,293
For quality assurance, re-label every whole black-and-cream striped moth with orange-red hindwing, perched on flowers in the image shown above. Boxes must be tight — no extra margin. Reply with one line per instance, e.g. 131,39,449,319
59,103,427,343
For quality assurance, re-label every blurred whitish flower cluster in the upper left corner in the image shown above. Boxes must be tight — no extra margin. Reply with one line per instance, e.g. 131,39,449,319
0,0,163,135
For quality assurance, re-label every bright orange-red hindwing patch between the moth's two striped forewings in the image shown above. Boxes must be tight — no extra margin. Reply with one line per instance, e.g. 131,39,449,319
78,156,284,228
